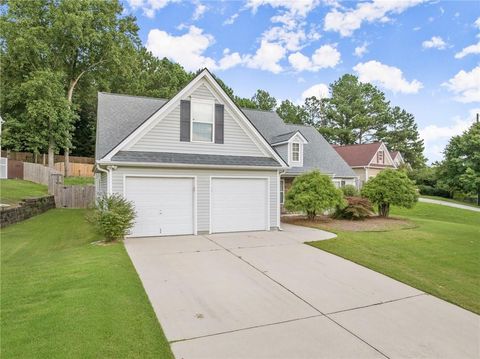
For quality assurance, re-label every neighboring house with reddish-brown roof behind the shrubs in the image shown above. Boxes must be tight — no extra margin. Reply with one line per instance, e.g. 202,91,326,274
333,142,396,186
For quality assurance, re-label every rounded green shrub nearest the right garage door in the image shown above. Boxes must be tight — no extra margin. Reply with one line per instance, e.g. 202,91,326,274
285,171,344,220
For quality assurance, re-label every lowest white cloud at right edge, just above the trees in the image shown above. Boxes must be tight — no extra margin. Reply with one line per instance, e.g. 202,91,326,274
419,108,480,162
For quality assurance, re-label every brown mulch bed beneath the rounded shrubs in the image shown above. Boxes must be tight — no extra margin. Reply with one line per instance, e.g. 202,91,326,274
282,216,416,232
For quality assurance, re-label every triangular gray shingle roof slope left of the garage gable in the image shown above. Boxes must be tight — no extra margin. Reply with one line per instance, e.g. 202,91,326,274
95,92,167,159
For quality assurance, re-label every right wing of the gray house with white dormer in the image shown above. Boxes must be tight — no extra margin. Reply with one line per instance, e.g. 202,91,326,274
242,109,358,210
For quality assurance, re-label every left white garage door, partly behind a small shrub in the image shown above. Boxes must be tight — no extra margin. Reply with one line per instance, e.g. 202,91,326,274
125,177,194,237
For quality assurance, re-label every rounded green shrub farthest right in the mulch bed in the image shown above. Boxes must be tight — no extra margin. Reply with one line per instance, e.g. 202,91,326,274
362,169,418,217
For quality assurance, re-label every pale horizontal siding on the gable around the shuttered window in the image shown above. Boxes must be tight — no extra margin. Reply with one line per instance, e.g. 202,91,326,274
127,84,270,157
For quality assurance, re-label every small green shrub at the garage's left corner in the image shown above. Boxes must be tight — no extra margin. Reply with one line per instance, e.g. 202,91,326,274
92,194,136,242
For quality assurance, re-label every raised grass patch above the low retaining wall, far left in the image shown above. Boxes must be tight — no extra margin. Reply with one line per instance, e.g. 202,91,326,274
0,179,48,205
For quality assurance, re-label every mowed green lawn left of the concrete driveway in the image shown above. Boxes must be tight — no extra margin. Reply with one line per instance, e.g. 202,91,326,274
0,209,173,359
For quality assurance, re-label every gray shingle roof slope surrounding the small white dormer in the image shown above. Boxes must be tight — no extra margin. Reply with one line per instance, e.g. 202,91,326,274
242,109,356,177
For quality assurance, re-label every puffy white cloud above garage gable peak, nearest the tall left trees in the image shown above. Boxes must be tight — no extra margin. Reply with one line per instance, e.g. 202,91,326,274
146,25,216,71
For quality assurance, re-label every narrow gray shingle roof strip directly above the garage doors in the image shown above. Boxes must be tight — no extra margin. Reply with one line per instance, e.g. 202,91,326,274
112,151,281,167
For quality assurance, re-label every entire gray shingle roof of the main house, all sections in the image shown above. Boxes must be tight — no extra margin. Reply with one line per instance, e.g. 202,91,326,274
95,92,355,177
